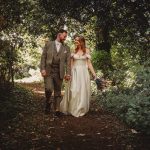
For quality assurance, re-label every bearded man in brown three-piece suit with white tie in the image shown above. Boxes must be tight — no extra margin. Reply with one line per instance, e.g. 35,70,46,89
40,29,71,117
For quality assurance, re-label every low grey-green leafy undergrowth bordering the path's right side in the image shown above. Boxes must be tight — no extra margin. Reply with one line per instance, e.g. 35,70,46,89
98,61,150,134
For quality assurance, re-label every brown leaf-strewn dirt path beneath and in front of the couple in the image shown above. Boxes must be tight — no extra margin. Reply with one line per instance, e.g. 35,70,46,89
0,84,150,150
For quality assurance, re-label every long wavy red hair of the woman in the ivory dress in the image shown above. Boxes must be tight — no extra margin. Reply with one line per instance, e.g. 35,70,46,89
74,36,86,55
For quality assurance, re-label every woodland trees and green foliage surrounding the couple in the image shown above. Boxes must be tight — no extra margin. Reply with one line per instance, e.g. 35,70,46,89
0,0,150,132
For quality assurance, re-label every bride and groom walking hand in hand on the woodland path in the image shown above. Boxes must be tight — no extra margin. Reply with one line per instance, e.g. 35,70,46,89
40,29,96,117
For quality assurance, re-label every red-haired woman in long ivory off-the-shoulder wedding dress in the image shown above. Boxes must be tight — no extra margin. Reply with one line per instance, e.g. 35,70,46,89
60,36,96,117
